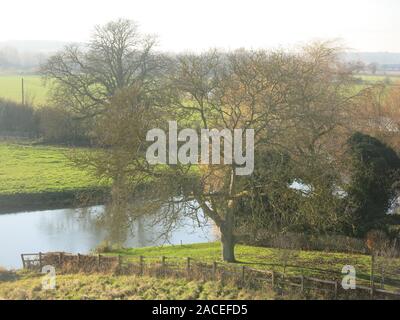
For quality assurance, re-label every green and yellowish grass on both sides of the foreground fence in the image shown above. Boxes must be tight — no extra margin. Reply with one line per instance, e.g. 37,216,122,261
0,242,399,300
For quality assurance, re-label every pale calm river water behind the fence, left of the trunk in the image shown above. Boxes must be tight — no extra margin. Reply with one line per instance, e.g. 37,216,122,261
0,206,216,269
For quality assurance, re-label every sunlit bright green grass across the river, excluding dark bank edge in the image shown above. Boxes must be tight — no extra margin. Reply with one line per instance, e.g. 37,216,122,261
0,143,98,195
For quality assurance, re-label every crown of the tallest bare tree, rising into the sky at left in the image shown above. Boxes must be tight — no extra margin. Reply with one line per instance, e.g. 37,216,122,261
41,19,160,118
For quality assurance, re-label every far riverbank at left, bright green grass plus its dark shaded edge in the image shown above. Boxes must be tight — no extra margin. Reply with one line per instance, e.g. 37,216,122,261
0,143,105,212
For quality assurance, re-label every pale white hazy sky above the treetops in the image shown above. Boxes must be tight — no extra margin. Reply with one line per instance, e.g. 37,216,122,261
0,0,400,52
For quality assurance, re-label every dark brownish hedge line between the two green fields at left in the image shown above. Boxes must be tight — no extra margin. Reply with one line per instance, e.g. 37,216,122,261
0,99,89,145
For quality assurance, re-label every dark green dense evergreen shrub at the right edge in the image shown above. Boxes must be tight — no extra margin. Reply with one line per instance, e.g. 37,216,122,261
346,132,400,237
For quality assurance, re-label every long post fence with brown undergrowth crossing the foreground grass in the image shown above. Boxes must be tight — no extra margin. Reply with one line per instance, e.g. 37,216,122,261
21,252,400,300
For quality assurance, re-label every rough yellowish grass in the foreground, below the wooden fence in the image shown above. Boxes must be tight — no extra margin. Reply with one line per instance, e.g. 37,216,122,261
0,273,275,300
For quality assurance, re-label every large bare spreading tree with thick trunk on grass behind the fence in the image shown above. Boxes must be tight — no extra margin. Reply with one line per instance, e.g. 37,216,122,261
72,44,361,262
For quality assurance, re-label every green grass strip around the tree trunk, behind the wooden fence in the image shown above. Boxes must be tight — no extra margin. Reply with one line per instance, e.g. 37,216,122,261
107,243,371,284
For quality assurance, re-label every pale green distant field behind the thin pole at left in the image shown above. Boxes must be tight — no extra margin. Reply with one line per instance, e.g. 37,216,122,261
0,75,48,105
